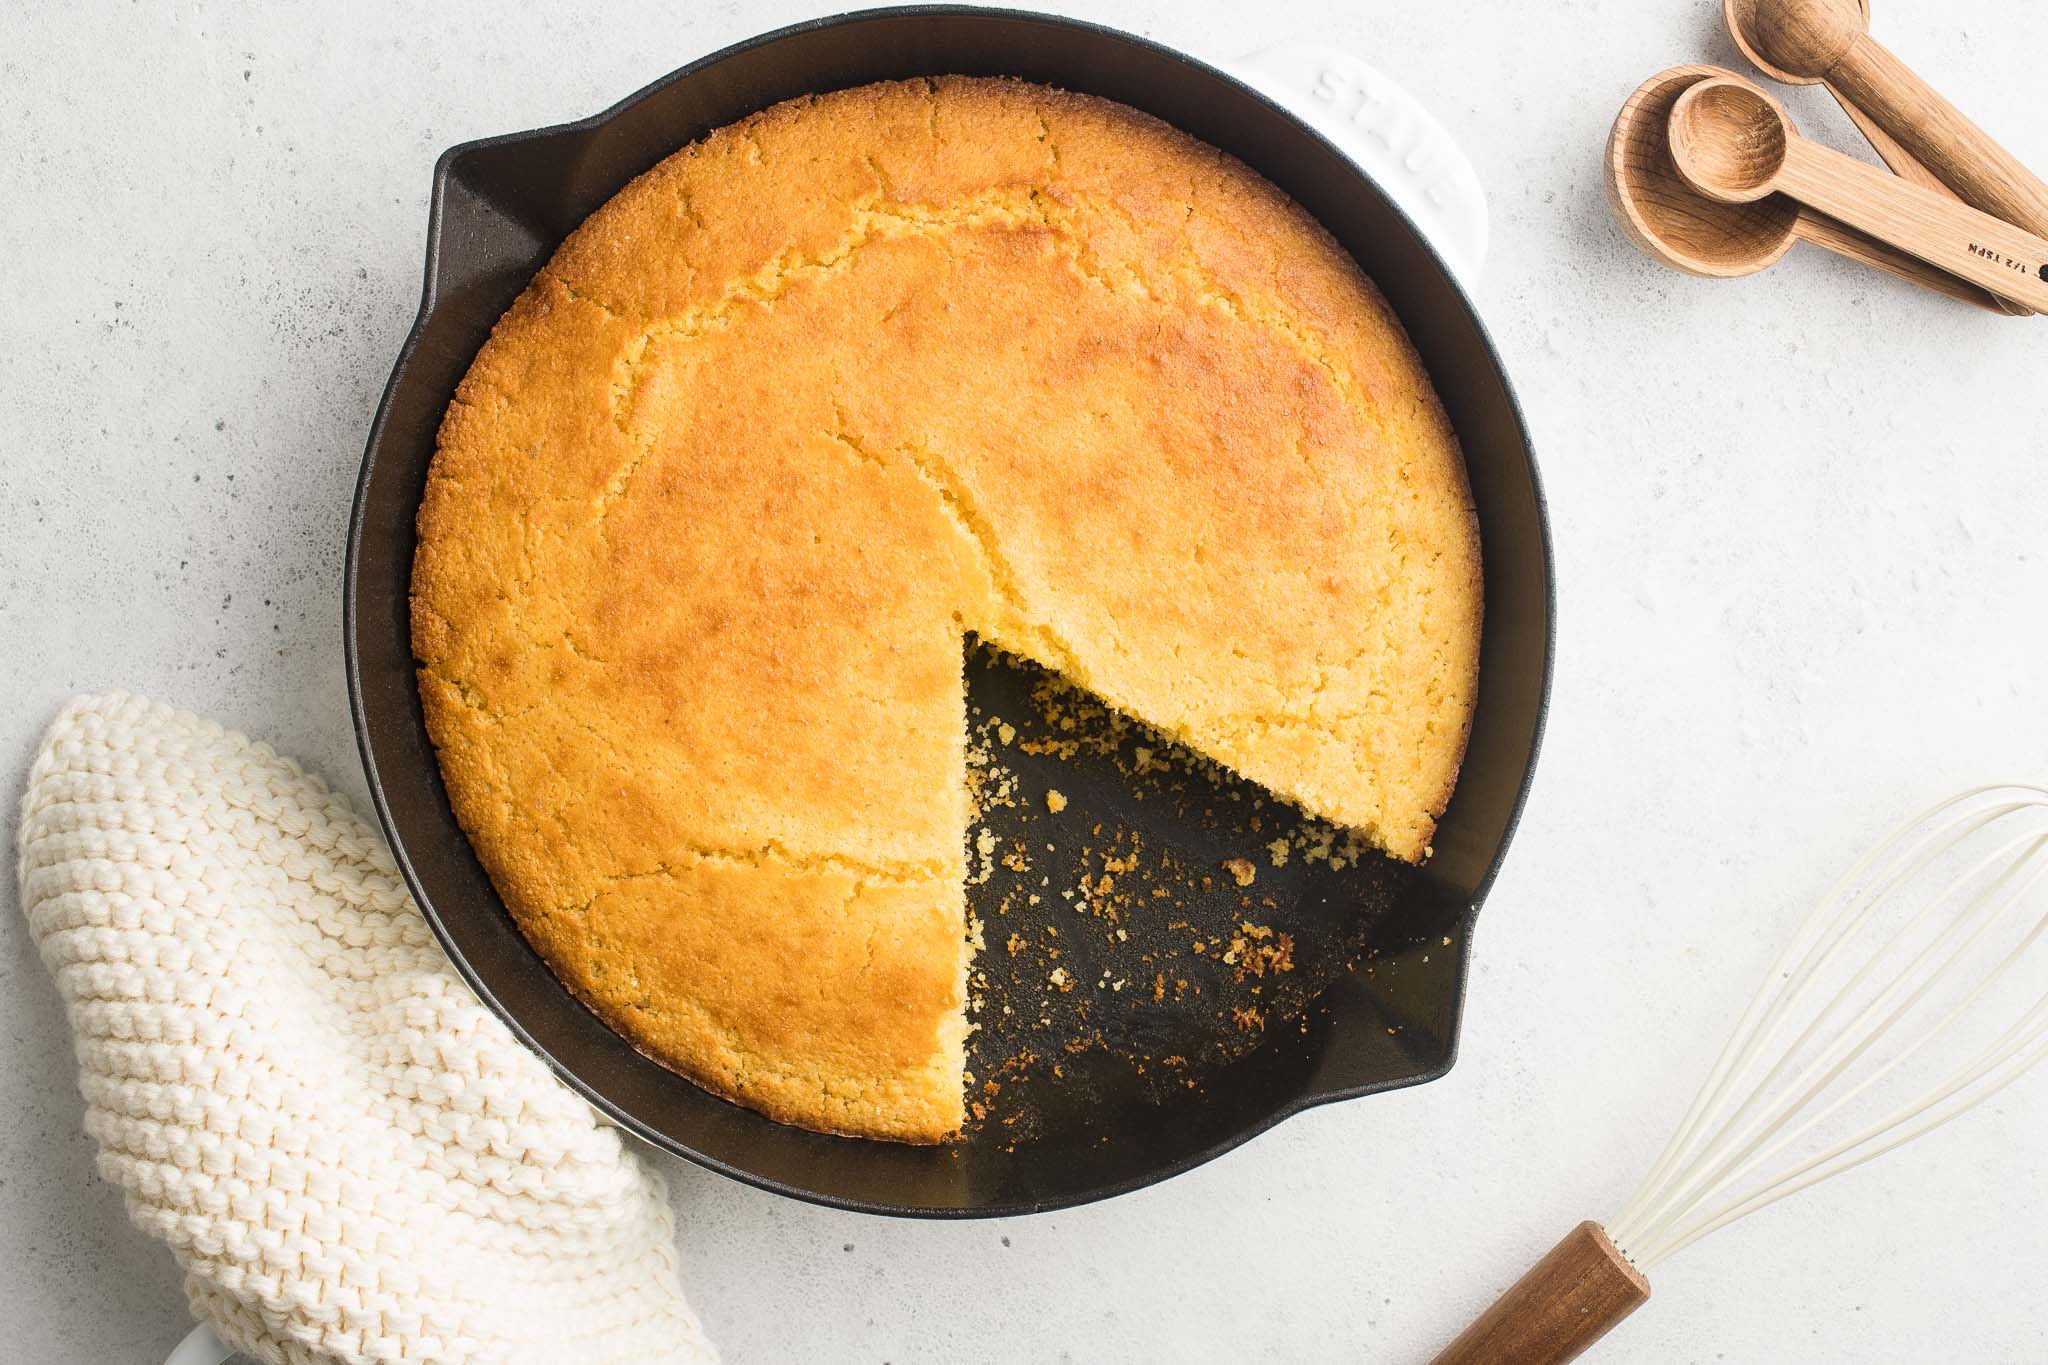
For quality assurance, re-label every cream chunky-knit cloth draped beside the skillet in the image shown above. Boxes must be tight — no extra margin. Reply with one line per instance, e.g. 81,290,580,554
18,694,717,1365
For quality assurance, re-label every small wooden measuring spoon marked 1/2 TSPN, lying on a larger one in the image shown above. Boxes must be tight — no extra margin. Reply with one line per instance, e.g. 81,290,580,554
1669,74,2048,309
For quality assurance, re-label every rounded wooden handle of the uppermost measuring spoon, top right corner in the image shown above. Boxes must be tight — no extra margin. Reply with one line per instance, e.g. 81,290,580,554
1827,33,2048,235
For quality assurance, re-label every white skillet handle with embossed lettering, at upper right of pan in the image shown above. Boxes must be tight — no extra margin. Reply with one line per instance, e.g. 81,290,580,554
1225,43,1487,289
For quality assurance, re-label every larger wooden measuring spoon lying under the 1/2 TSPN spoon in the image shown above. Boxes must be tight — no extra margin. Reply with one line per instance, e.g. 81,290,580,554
1606,65,1997,311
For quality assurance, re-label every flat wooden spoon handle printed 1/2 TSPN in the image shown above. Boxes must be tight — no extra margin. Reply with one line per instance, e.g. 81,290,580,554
1772,137,2048,311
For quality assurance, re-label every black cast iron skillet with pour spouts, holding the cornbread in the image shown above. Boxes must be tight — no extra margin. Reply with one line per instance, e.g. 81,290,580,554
346,6,1552,1216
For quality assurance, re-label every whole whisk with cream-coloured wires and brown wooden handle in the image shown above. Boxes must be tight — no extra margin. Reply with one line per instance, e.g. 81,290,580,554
1434,784,2048,1365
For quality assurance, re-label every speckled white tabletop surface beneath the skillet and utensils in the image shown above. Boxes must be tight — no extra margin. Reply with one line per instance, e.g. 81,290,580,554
0,0,2048,1365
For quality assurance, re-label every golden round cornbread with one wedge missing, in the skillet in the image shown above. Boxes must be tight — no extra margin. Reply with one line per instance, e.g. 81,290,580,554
412,78,1481,1142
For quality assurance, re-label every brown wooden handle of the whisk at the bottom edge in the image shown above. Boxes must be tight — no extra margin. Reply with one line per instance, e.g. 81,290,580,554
1432,1220,1651,1365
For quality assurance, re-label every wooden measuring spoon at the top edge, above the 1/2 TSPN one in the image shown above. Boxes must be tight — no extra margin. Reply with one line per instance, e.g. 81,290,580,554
1722,0,2048,235
